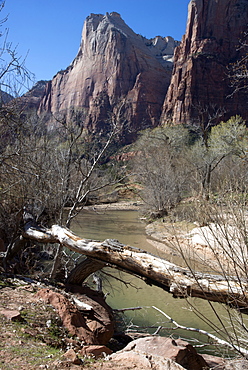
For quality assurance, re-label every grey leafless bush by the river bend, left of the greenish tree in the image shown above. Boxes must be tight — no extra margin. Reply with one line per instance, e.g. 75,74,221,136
134,127,188,217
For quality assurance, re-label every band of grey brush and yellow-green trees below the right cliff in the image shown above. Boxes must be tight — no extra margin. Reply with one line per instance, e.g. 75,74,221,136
134,116,248,217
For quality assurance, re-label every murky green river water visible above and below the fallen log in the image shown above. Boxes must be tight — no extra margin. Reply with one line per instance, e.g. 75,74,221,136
72,210,246,352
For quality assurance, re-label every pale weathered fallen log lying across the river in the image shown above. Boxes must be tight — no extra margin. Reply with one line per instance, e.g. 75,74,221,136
23,225,248,310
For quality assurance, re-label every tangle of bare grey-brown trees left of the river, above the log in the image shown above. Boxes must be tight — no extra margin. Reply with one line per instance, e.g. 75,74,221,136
0,110,123,277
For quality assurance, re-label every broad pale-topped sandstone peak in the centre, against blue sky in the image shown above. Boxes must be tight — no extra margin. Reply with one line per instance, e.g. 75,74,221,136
38,12,177,143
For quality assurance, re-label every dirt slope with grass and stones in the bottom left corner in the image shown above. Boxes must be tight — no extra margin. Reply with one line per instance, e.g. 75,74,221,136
0,277,149,370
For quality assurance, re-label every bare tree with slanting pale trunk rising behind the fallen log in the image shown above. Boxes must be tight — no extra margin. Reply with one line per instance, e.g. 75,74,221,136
46,115,120,277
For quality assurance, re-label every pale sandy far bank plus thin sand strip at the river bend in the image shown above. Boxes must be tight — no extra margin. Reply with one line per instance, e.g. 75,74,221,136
88,201,237,273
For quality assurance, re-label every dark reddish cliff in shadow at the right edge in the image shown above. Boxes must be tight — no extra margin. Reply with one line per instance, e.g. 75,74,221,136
161,0,248,123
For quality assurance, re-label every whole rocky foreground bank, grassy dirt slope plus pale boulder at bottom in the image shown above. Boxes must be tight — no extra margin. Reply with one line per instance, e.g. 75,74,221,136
0,275,248,370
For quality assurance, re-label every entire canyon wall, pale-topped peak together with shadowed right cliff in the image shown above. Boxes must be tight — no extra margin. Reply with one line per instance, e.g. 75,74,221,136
22,0,248,139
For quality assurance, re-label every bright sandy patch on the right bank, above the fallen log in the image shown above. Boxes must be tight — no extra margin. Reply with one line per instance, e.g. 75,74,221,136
146,221,237,274
